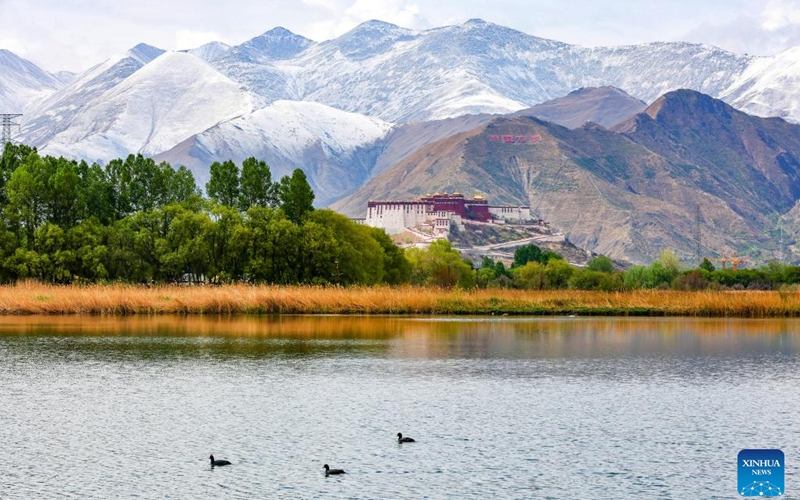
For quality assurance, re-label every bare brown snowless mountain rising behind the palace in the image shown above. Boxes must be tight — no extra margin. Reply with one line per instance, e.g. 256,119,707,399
334,91,800,262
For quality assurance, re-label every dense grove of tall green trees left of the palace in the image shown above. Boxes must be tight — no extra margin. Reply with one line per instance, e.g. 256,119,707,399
0,144,410,285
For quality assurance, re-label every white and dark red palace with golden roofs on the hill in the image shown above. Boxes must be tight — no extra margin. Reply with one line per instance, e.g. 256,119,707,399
364,192,531,236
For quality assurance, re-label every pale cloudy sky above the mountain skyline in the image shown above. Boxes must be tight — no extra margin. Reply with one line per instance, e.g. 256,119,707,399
0,0,800,71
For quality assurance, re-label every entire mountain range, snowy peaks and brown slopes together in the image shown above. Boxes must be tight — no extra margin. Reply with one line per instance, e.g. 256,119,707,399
0,20,800,262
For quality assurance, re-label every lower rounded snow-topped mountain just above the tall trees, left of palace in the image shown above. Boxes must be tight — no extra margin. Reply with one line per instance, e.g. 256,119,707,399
156,101,392,205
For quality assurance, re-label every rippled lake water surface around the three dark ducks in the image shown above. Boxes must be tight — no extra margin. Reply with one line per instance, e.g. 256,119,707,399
0,317,800,499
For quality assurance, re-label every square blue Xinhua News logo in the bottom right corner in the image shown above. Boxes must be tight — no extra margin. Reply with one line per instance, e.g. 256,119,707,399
739,450,786,497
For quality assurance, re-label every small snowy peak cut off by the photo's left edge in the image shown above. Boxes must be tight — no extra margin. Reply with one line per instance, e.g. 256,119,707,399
0,49,66,113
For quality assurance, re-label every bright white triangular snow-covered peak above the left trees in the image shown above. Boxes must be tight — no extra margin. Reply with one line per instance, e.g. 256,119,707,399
42,52,263,161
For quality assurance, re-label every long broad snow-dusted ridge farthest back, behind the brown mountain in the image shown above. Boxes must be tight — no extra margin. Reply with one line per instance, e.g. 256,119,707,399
234,20,753,122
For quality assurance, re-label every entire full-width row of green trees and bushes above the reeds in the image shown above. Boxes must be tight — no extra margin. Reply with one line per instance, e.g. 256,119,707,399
6,144,800,291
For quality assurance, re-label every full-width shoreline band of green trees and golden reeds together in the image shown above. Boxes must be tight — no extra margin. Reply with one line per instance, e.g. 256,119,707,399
0,139,800,317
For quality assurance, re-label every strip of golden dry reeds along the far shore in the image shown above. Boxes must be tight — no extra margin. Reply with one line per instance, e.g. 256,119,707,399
0,282,800,318
